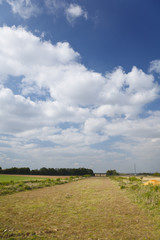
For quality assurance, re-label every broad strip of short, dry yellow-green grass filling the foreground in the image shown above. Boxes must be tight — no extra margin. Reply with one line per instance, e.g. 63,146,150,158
0,178,160,240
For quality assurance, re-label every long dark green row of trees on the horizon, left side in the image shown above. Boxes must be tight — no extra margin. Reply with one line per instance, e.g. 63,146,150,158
0,167,94,176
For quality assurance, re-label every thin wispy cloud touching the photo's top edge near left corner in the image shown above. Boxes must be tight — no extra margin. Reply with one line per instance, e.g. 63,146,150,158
7,0,41,19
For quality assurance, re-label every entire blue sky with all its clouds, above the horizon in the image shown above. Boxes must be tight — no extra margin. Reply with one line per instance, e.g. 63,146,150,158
0,0,160,172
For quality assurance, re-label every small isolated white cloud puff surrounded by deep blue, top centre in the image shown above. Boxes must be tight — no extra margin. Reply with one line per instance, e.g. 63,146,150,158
65,3,88,23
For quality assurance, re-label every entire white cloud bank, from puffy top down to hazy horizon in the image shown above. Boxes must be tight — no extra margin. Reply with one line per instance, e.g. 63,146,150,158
0,26,160,171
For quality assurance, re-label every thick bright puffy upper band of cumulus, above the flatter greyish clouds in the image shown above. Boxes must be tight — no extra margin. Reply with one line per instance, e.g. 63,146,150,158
0,27,159,118
